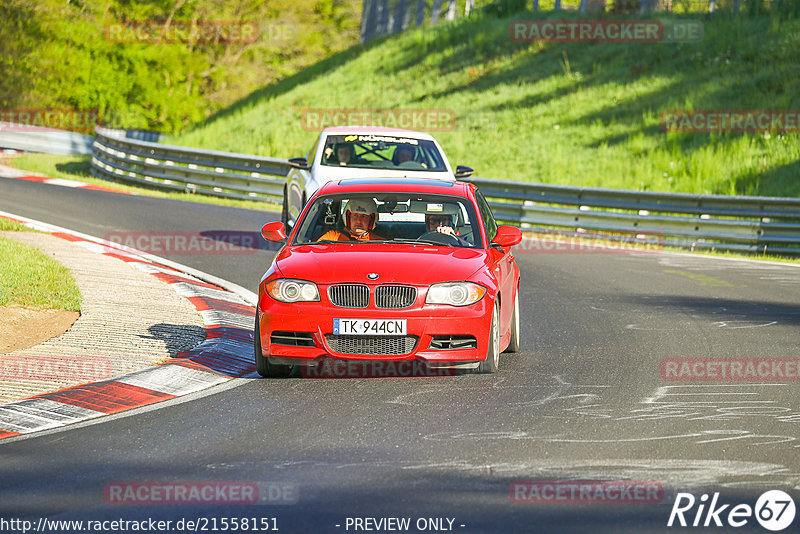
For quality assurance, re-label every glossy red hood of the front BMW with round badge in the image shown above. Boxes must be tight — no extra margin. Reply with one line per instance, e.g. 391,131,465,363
276,243,486,285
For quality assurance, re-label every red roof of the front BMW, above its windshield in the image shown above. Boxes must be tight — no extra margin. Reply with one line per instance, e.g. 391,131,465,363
319,178,473,197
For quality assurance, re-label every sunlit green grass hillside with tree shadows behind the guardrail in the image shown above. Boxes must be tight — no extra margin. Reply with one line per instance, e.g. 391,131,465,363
168,5,800,197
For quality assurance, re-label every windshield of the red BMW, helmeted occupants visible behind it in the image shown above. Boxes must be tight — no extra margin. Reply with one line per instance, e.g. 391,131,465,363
292,193,483,248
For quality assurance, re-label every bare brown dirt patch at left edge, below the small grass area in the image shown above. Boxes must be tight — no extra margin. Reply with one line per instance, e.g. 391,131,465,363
0,306,81,354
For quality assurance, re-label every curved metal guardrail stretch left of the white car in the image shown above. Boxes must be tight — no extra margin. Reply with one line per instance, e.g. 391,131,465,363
92,128,289,203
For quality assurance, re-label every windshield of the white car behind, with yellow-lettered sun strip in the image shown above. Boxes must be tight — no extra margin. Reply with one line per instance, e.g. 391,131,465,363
322,134,447,172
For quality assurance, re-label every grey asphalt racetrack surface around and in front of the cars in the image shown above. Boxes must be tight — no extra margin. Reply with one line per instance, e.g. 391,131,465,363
0,180,800,533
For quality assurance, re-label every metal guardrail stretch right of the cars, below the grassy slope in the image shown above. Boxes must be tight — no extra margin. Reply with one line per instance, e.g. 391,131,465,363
470,178,800,255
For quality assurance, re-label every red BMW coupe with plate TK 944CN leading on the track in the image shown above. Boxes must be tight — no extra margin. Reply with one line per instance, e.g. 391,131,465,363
255,178,522,377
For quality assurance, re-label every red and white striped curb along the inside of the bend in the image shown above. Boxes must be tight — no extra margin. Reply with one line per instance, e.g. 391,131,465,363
0,212,257,439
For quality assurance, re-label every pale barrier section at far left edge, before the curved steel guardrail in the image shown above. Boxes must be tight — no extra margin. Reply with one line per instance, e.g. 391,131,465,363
0,122,94,156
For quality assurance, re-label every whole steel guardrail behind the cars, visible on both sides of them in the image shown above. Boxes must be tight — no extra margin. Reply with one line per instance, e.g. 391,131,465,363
86,128,800,255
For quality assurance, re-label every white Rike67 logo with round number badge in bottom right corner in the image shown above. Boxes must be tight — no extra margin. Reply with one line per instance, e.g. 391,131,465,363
667,490,796,532
